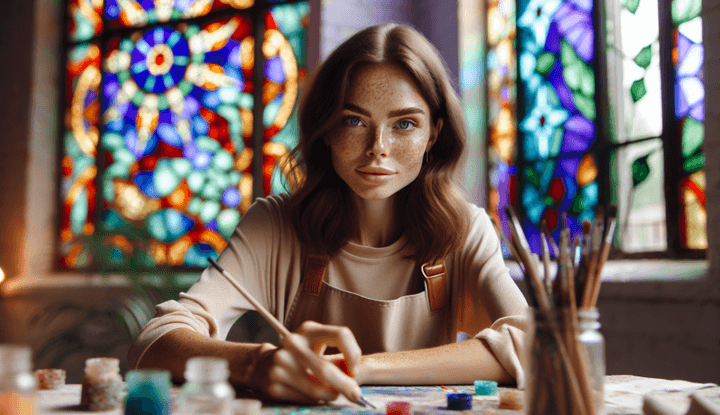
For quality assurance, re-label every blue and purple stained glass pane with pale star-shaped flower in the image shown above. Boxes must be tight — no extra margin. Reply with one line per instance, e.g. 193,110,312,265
518,0,598,252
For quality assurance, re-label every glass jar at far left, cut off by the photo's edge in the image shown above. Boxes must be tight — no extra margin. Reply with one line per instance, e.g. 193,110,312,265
0,344,37,415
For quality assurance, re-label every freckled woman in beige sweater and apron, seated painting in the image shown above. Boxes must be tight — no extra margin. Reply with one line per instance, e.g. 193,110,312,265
130,24,527,403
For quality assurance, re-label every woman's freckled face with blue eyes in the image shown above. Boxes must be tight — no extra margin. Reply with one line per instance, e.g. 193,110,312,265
326,64,442,200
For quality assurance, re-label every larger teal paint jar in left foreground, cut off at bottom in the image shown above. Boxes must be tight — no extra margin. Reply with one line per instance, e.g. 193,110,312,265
125,370,171,415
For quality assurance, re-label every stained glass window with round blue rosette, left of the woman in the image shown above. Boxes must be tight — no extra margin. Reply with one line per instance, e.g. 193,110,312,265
60,0,309,270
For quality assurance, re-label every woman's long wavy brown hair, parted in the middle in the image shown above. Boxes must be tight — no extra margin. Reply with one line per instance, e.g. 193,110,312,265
287,24,468,263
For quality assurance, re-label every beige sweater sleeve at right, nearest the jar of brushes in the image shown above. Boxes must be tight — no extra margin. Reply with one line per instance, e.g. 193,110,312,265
459,205,528,389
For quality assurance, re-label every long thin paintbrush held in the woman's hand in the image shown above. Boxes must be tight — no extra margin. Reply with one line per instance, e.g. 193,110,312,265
208,258,377,409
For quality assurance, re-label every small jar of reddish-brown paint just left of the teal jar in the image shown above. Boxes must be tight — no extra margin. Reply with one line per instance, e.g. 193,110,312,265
80,357,123,411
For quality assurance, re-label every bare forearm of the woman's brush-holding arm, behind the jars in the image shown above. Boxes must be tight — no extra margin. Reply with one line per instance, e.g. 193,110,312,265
137,328,275,389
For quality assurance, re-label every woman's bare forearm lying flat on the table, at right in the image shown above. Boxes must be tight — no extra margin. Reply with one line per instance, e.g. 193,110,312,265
357,339,515,385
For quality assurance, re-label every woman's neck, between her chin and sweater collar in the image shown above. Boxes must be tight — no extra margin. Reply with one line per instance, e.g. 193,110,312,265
350,195,401,248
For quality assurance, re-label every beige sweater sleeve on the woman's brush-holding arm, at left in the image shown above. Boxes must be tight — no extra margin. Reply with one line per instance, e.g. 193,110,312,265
128,200,286,368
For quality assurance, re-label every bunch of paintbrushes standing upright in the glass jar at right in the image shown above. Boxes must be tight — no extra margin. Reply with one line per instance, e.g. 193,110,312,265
494,206,617,415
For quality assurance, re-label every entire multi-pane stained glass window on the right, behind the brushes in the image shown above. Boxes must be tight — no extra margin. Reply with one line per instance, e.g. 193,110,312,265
485,0,707,255
